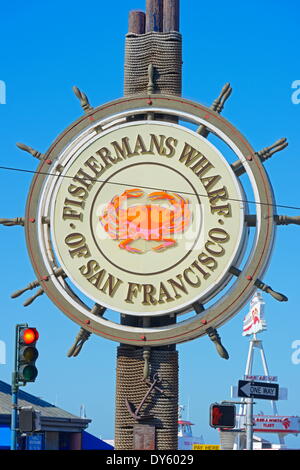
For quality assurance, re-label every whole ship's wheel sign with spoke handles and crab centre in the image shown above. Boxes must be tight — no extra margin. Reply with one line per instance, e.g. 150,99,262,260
2,93,287,346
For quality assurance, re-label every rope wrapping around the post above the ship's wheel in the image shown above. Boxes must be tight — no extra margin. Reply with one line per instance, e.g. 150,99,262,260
124,31,182,96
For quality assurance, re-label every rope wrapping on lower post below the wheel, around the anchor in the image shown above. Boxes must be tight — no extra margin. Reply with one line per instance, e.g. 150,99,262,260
115,346,178,450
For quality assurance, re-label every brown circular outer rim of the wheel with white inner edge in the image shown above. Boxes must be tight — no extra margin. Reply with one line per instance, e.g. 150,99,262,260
25,95,275,346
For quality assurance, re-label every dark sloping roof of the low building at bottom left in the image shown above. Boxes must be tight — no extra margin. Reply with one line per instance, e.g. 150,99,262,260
0,380,91,428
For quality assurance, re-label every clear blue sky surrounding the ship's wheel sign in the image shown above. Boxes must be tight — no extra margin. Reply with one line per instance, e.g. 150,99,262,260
0,0,300,447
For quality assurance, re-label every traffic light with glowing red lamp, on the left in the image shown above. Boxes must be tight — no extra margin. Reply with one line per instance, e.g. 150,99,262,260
17,327,39,384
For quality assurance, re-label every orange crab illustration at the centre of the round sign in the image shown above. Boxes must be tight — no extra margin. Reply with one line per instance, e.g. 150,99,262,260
100,188,191,253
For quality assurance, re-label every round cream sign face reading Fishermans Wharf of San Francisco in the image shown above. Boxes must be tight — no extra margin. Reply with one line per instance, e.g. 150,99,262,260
51,121,245,316
